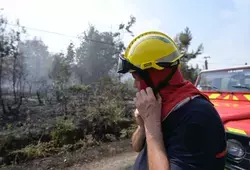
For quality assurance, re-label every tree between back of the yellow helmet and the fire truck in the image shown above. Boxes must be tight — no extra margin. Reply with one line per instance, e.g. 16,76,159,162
175,27,204,83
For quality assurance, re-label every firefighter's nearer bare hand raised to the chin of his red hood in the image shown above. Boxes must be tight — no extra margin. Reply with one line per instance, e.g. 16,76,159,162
135,87,162,137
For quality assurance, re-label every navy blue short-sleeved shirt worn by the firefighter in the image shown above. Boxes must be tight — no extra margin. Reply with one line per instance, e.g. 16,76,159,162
134,97,226,170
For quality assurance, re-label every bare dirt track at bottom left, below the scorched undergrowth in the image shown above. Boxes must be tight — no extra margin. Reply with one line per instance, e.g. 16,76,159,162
1,140,137,170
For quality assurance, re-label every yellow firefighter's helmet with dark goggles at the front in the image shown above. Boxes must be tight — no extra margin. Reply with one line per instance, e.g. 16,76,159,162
118,31,183,73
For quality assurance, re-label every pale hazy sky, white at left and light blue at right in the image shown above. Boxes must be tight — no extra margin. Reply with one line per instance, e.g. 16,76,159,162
0,0,250,69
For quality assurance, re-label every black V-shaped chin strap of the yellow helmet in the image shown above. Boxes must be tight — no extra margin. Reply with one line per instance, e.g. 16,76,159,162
135,64,178,96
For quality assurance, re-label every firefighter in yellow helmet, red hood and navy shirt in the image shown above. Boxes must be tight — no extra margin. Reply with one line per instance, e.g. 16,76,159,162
118,31,226,170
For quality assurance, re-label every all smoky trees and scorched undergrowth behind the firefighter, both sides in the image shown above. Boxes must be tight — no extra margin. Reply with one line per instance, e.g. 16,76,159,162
0,11,203,165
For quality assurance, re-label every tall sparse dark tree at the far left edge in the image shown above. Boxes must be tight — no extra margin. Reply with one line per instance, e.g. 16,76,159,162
0,15,25,115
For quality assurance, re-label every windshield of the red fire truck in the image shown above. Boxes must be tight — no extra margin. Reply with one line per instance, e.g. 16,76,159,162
196,68,250,92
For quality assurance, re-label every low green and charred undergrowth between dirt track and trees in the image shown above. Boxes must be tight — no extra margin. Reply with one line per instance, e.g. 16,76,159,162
0,76,137,164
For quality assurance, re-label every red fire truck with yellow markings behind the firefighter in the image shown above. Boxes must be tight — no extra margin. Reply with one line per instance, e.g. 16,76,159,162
195,65,250,170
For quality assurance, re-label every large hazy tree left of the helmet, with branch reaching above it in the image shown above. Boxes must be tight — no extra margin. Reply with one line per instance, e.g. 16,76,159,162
76,16,135,83
